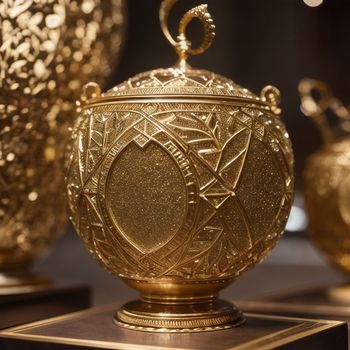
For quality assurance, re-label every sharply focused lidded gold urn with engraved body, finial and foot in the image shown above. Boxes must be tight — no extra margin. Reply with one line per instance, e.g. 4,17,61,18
66,0,293,332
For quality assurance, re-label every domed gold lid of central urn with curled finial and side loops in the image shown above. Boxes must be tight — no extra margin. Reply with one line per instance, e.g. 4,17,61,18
80,0,280,114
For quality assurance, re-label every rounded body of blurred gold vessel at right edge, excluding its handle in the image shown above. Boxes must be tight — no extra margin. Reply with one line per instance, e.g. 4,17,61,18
304,138,350,275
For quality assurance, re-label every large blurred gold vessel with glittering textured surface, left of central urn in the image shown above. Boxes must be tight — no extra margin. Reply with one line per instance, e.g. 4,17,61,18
0,0,125,293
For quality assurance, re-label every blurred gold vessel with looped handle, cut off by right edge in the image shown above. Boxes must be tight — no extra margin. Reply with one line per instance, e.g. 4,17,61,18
299,79,350,274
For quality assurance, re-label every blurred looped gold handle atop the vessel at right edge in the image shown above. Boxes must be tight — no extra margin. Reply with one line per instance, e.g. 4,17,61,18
298,79,350,144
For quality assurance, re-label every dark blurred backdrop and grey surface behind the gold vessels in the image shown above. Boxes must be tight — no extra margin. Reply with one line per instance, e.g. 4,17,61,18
38,0,350,304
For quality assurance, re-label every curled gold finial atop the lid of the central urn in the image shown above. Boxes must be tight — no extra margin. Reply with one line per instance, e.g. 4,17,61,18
159,0,215,60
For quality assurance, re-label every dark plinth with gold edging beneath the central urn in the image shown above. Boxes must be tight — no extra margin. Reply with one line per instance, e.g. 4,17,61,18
0,305,347,350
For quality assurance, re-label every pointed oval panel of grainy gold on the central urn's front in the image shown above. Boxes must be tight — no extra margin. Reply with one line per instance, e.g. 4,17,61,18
106,141,188,253
